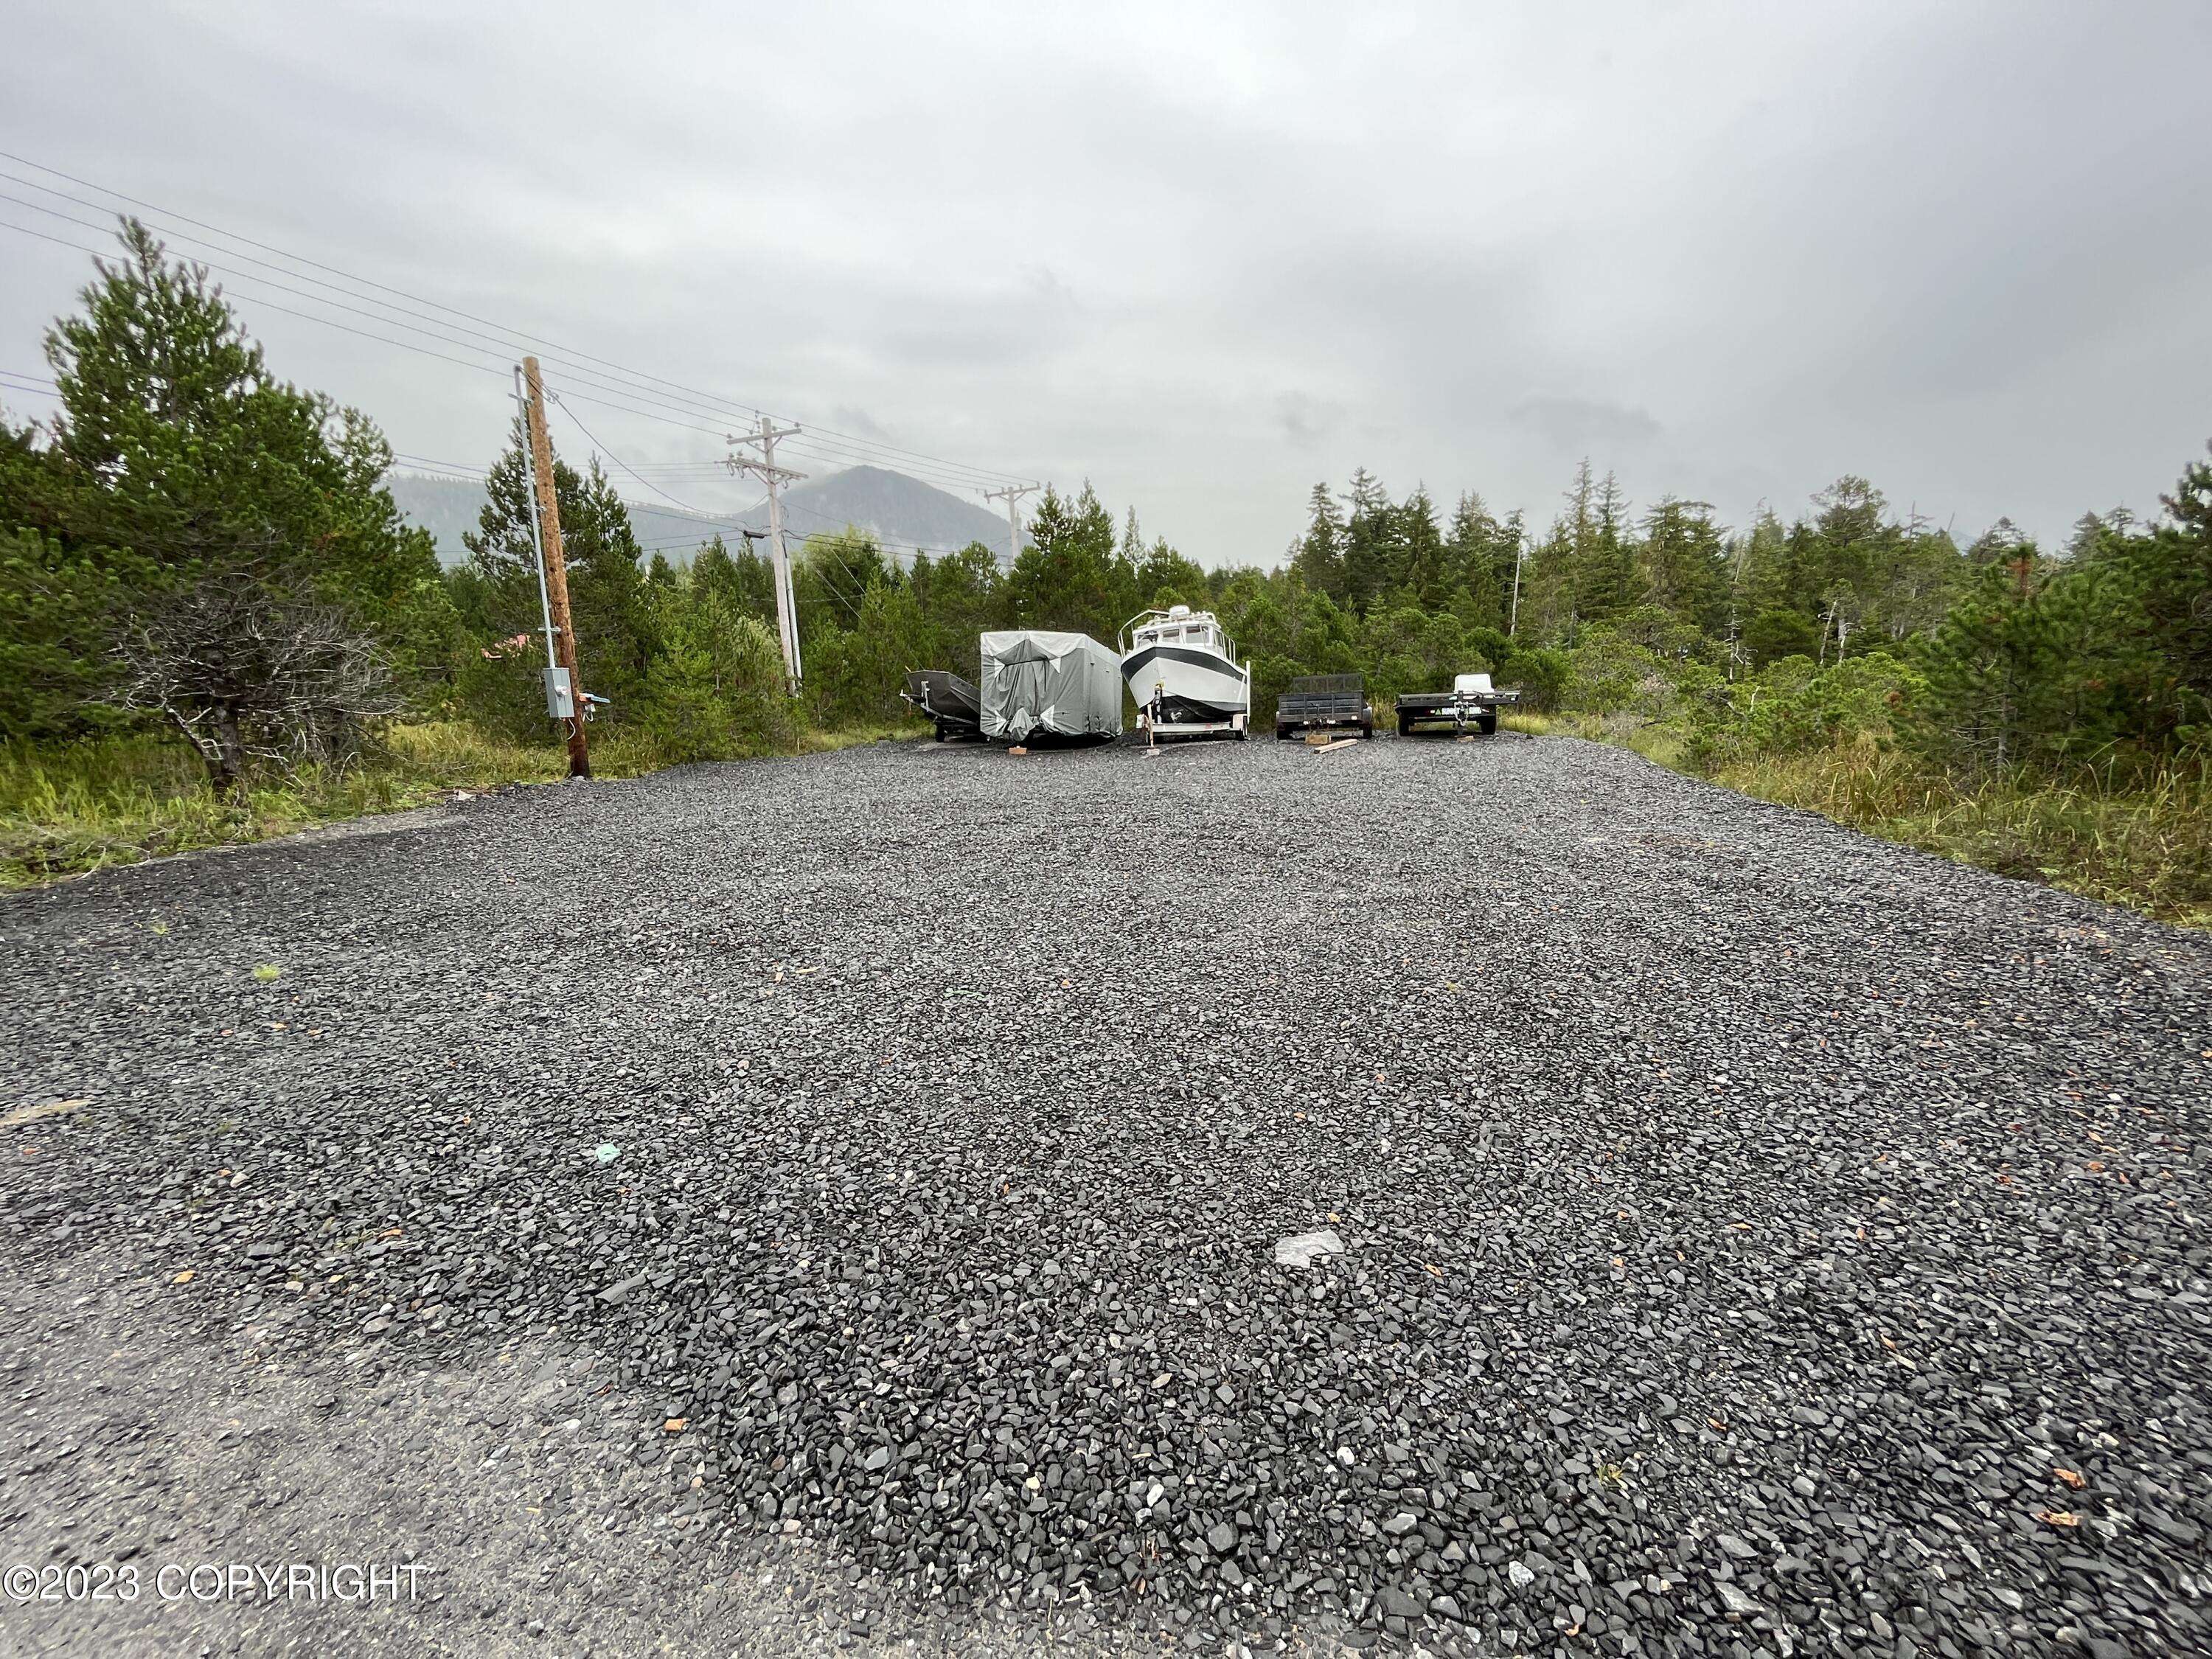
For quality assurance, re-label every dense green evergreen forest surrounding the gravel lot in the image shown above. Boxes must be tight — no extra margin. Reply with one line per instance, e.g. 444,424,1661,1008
0,221,2212,916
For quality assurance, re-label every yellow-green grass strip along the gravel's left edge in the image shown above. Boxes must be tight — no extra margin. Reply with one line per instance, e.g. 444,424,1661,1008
0,721,922,889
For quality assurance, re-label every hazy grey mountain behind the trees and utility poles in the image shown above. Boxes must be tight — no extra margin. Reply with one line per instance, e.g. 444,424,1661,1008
387,467,1006,564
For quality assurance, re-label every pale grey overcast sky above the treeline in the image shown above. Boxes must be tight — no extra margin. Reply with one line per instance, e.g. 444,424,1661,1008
0,0,2212,564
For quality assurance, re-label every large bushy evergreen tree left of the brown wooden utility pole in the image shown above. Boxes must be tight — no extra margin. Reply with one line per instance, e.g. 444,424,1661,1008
18,219,451,787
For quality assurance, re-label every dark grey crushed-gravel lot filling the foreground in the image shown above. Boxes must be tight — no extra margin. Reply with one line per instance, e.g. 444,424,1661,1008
0,737,2212,1659
